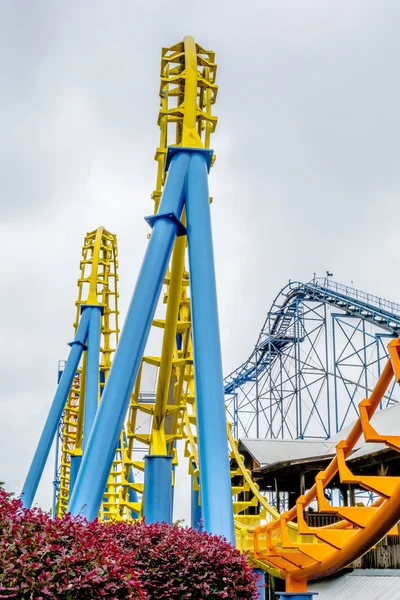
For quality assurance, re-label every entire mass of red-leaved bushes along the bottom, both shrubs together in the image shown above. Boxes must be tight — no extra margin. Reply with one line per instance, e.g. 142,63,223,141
0,489,256,600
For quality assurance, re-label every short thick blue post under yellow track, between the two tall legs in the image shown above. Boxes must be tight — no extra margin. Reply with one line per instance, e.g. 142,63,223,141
143,454,172,524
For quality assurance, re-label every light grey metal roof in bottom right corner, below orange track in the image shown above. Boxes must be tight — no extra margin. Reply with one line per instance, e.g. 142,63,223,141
308,569,400,600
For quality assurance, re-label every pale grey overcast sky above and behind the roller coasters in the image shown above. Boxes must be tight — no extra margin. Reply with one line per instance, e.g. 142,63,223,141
0,0,400,516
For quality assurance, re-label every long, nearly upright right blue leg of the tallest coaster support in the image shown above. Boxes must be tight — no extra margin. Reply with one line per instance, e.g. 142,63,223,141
186,152,235,544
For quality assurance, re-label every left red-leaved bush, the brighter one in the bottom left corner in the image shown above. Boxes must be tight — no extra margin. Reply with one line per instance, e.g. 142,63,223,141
0,490,147,600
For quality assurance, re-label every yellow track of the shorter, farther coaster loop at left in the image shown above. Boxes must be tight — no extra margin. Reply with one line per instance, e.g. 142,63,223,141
57,227,119,516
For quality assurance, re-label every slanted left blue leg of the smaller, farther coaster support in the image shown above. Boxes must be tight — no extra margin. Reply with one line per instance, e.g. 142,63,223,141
21,310,90,508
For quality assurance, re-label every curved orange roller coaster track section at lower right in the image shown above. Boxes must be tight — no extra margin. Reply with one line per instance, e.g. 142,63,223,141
254,339,400,592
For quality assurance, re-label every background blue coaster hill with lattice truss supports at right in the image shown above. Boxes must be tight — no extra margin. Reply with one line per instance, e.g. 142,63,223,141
224,277,400,439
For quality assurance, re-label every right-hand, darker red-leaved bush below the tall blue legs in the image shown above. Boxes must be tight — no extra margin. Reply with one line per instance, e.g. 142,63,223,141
112,523,256,600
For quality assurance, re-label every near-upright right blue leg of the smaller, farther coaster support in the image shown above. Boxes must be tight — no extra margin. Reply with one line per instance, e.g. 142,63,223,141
83,306,102,452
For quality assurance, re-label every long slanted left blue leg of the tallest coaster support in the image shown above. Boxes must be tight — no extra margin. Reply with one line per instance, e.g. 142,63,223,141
69,151,189,521
